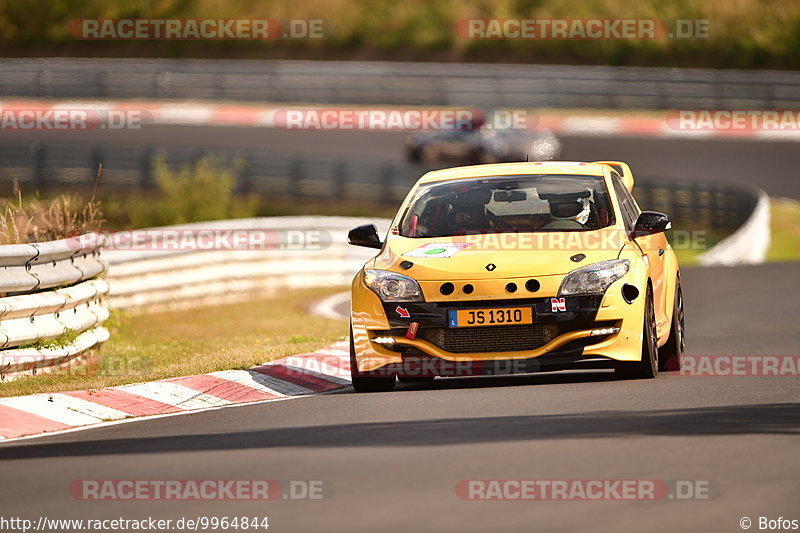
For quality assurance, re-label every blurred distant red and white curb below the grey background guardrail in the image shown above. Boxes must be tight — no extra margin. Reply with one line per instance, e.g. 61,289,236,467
0,100,800,141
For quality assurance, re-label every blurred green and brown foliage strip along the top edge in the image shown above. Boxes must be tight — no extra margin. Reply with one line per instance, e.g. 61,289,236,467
0,0,800,68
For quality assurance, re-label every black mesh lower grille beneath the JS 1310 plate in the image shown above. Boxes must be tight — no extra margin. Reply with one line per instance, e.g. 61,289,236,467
419,324,558,353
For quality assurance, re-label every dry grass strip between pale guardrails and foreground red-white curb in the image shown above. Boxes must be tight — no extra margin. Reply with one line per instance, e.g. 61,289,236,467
0,288,347,397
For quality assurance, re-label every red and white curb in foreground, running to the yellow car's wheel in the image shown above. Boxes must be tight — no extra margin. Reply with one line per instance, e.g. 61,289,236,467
0,341,350,442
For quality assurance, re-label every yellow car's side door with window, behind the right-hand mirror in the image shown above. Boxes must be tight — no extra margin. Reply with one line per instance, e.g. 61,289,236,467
611,172,667,328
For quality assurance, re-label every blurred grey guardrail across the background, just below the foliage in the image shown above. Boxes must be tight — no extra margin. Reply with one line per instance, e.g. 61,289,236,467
0,58,800,109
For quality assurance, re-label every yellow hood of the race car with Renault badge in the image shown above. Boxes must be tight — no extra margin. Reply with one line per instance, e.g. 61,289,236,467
373,231,619,281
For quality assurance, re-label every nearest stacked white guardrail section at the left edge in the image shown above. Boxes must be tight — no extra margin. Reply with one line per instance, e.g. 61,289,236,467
0,234,109,379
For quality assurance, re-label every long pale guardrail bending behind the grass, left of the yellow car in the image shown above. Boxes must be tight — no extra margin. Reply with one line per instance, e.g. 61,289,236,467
104,217,389,310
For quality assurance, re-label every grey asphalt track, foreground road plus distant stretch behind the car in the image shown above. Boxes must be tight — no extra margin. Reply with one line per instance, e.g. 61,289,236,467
0,122,800,532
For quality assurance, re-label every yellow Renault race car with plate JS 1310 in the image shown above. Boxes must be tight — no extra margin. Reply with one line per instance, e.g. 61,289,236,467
348,161,684,392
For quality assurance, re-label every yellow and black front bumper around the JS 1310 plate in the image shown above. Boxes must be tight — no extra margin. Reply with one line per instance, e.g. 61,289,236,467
352,274,644,376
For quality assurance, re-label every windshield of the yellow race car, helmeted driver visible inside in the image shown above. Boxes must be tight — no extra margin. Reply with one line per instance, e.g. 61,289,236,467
400,174,614,238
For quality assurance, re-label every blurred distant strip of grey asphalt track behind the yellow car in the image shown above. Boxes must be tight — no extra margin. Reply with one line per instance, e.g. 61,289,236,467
0,125,800,198
